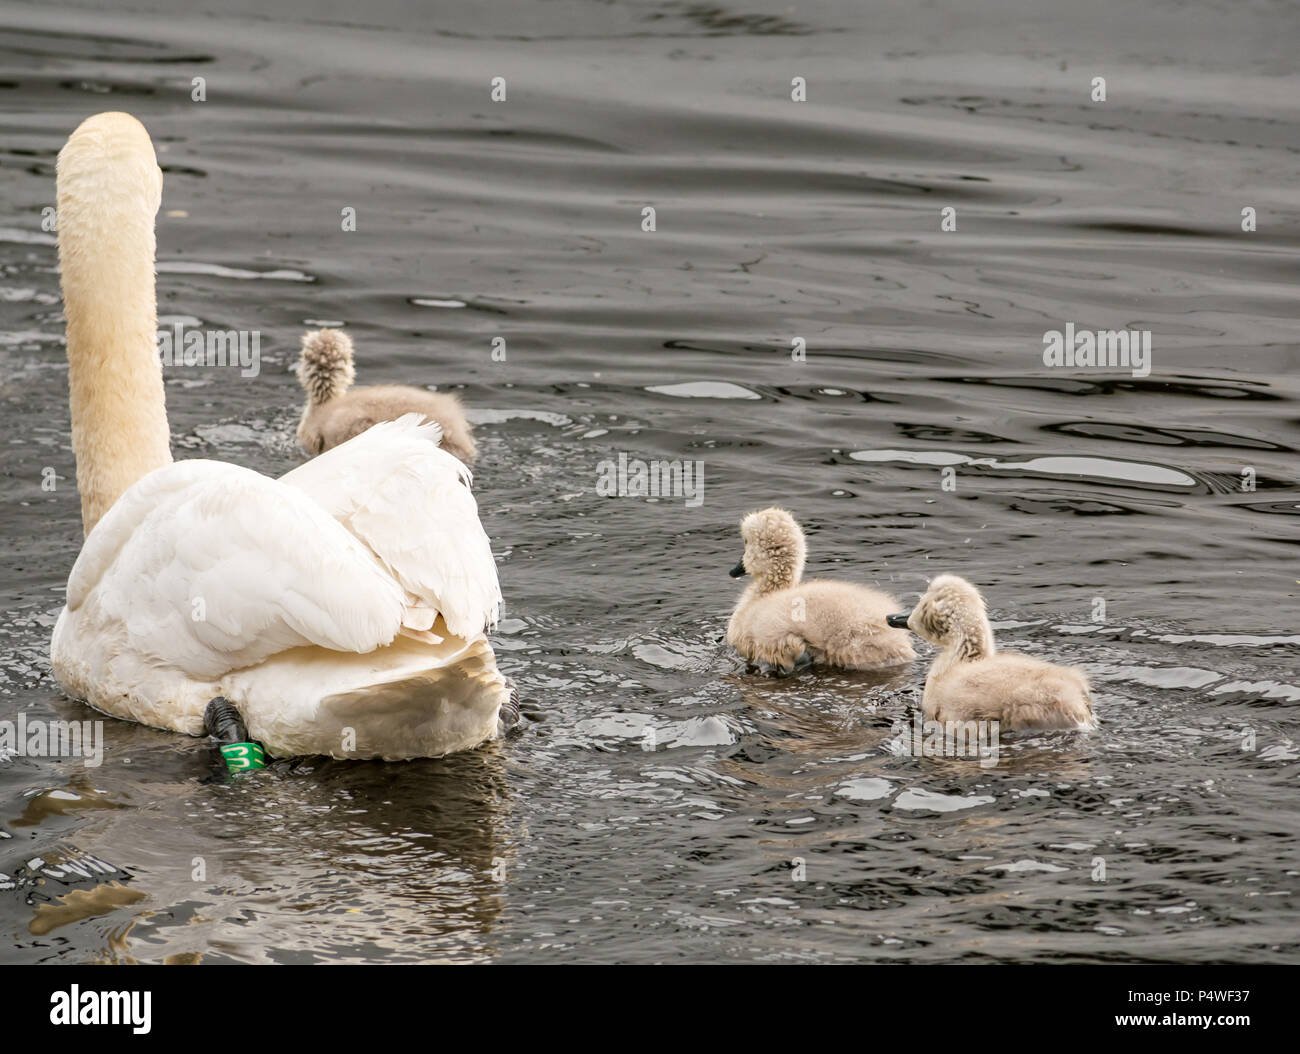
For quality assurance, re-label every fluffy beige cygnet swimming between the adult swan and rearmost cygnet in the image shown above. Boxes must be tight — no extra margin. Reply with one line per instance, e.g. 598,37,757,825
727,508,917,672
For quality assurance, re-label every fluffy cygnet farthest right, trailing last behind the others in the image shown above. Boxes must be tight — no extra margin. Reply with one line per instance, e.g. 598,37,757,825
889,574,1096,730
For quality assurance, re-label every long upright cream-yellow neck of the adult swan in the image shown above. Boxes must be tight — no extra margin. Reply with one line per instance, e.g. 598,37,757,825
57,118,172,534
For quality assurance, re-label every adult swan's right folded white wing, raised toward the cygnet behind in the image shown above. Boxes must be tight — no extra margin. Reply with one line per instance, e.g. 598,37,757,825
280,413,502,638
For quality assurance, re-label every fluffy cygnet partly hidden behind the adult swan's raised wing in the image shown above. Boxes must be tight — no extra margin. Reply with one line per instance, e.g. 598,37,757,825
298,329,477,465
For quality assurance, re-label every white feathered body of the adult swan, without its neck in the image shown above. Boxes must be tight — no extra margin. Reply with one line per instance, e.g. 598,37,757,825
51,416,503,758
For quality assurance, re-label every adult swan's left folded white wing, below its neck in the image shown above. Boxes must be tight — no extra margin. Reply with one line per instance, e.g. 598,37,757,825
68,460,404,677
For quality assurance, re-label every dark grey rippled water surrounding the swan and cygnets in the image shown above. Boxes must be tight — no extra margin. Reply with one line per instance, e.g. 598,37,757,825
0,0,1300,963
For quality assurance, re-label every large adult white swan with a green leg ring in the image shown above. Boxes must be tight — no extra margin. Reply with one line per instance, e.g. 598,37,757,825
51,113,508,760
